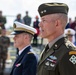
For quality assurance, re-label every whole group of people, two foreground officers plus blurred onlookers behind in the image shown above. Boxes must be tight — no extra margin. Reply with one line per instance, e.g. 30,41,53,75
0,2,76,75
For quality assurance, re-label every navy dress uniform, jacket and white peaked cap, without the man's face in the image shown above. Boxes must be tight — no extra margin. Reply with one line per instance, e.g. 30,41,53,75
10,21,37,75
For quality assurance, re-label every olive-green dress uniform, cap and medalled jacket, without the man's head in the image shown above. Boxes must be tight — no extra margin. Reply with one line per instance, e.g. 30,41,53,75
37,3,76,75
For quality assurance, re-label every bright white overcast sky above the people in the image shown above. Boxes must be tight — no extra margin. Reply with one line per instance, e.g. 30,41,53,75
0,0,76,28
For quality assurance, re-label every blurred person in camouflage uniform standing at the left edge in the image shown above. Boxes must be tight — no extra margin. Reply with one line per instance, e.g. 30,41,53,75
0,29,10,75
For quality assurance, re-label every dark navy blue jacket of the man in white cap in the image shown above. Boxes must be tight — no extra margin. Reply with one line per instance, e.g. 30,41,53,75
10,46,37,75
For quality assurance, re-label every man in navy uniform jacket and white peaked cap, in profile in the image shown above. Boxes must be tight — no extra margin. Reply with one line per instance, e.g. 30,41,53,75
10,21,37,75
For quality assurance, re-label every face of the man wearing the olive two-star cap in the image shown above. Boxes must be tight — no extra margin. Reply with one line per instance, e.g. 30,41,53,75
39,15,56,39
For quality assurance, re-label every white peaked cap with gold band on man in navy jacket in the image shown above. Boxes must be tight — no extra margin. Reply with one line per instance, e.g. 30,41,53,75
11,21,37,35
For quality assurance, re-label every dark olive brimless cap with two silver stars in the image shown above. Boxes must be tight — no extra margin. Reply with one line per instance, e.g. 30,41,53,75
38,2,69,17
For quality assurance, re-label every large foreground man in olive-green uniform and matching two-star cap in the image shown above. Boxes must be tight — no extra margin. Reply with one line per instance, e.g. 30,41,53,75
37,2,76,75
